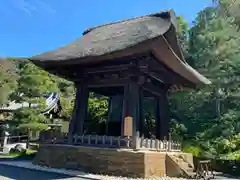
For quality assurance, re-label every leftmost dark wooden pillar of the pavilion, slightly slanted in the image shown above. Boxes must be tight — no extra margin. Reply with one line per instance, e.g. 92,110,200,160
68,84,89,143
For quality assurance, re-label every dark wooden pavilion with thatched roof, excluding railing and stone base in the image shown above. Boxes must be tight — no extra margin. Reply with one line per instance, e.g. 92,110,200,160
30,11,210,148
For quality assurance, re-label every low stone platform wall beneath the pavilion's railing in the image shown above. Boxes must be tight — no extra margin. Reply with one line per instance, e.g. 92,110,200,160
33,144,166,178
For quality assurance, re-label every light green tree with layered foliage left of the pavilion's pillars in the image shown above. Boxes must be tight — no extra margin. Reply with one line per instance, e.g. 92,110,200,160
14,62,58,131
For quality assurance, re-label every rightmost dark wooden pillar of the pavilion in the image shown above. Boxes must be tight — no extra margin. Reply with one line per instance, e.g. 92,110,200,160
156,90,170,140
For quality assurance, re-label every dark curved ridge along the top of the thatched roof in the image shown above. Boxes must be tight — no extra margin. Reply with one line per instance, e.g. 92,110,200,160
82,9,172,35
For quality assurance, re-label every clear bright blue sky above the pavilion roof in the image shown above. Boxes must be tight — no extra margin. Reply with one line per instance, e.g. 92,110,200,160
0,0,214,57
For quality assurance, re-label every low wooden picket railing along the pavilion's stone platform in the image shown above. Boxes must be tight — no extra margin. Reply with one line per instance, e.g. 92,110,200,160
42,135,181,152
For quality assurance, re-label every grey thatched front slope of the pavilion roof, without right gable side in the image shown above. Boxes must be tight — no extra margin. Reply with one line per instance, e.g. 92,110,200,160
31,12,175,61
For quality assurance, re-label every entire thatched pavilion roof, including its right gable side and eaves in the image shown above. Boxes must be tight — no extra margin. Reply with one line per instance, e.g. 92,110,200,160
30,11,210,84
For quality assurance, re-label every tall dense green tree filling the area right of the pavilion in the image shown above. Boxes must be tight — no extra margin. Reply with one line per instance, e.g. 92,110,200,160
170,4,240,156
